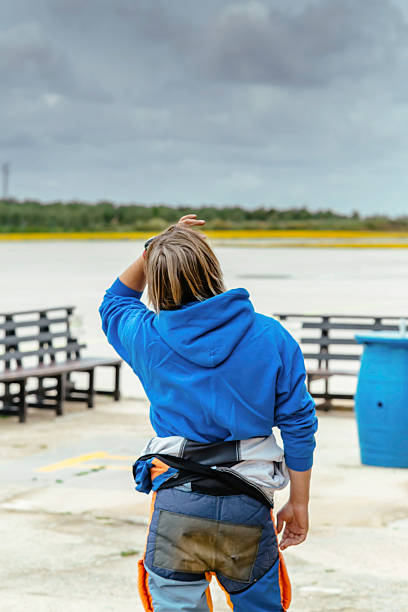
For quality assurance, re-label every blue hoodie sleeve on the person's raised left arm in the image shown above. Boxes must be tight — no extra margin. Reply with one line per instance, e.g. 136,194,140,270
99,278,152,373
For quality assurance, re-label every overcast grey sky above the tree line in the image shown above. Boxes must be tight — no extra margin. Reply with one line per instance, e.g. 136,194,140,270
0,0,408,214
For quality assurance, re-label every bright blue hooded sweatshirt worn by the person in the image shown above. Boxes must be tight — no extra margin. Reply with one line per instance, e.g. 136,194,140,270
99,279,317,471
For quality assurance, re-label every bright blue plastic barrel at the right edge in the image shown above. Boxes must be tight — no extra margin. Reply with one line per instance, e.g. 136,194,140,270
355,332,408,468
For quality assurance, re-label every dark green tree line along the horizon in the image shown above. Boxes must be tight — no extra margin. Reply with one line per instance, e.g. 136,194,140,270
0,199,408,233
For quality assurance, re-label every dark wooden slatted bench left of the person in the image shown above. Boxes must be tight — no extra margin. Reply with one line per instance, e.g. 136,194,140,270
0,306,122,422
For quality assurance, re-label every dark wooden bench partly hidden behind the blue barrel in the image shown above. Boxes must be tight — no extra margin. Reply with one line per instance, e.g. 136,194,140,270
273,313,399,410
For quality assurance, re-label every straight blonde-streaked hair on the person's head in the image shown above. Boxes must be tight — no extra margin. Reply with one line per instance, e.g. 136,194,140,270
145,225,225,312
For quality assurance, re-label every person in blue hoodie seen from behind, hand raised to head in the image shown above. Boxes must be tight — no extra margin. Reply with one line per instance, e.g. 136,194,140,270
100,214,317,612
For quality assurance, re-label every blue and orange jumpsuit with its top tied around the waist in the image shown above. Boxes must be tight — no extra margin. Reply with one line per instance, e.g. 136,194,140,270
133,435,291,612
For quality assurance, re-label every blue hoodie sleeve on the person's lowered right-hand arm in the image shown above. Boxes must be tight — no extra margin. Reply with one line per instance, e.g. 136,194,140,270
275,334,317,472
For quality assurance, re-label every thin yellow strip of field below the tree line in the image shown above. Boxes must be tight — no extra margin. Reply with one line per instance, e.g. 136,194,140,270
0,230,408,248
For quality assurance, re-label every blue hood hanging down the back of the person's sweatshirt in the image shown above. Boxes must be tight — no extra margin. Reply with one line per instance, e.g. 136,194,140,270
155,288,255,368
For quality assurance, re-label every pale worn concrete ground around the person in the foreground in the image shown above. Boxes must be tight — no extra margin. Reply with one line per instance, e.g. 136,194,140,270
0,399,408,612
